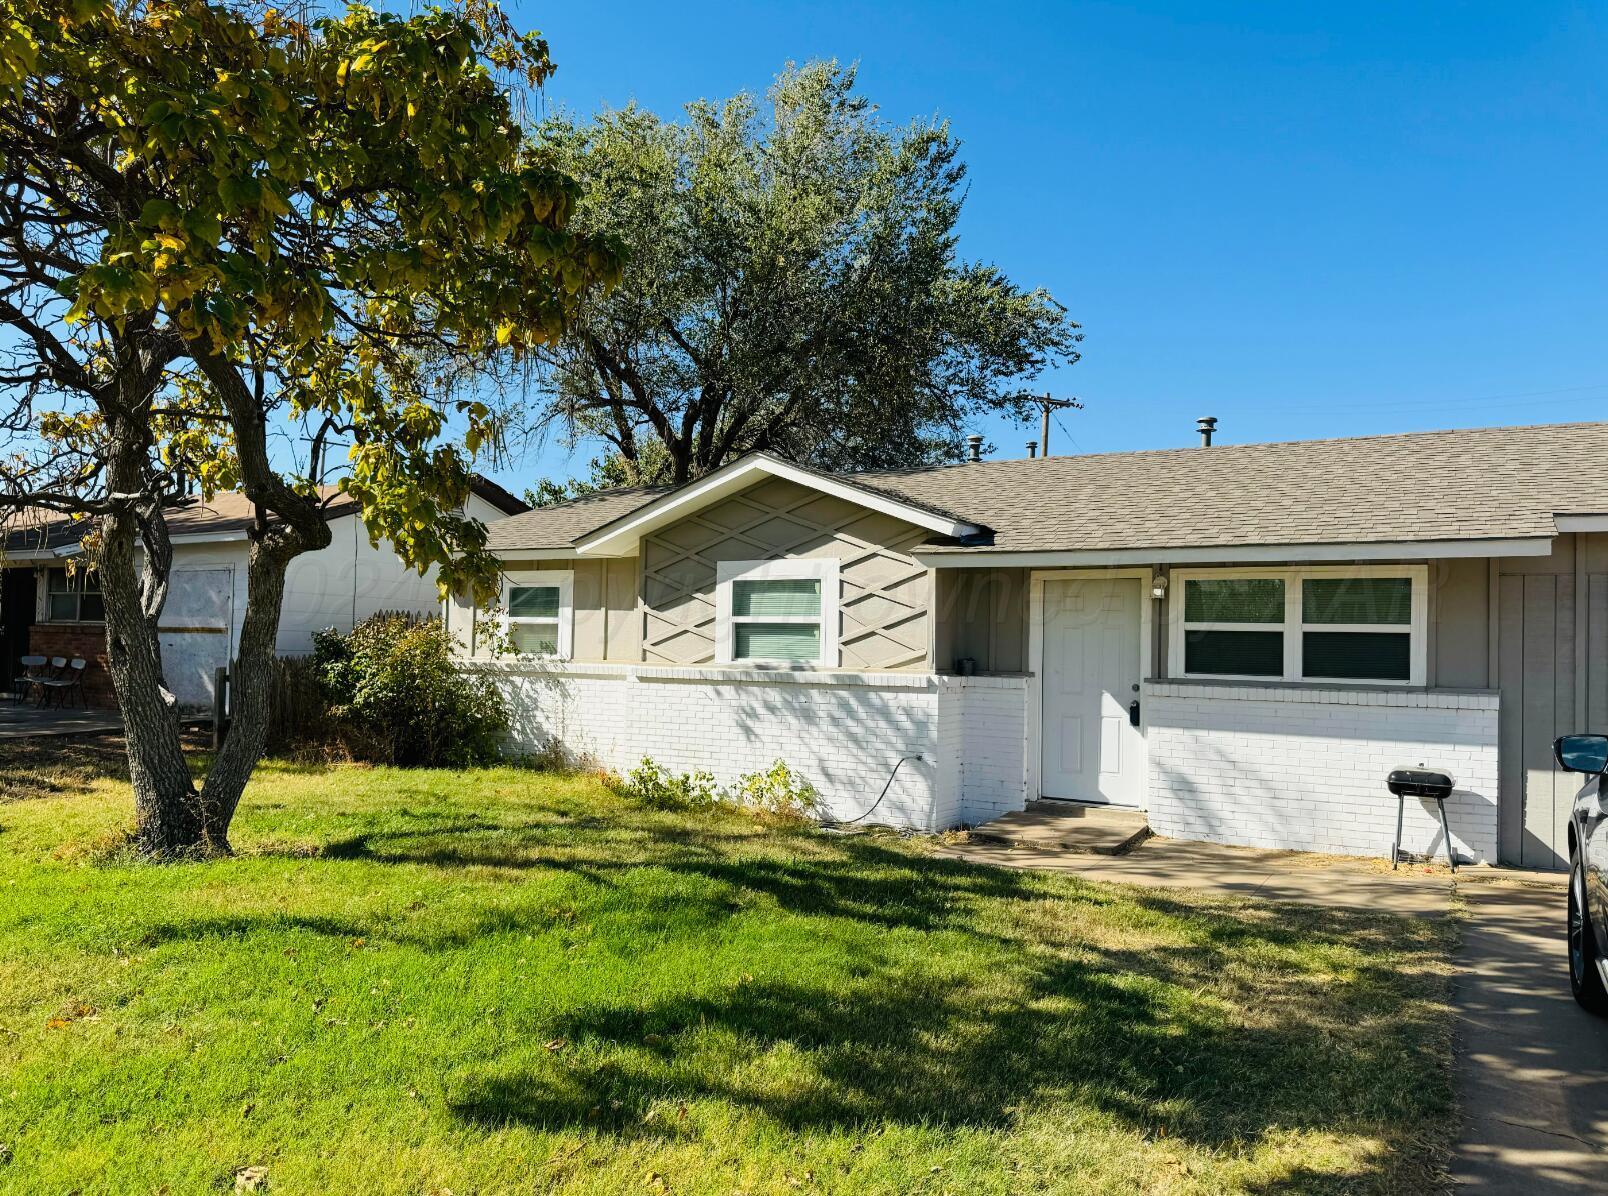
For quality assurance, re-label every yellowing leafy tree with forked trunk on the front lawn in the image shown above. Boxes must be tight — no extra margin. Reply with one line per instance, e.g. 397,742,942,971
0,0,617,854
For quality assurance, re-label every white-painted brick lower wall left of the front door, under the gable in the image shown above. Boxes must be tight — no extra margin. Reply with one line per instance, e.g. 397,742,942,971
471,662,1024,829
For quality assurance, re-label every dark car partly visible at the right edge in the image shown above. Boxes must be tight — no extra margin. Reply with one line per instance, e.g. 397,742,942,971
1552,735,1608,1016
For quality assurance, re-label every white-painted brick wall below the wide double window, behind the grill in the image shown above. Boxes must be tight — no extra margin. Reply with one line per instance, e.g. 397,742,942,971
1145,682,1499,862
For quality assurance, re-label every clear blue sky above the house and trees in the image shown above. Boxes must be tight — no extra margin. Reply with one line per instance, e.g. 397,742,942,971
498,0,1608,487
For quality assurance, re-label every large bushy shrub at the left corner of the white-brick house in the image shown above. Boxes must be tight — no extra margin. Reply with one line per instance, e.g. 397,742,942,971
314,614,508,765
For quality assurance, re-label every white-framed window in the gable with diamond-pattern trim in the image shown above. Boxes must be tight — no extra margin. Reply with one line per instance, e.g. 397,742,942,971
716,561,838,666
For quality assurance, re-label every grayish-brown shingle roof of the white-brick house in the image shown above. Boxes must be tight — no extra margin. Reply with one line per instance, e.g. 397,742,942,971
453,423,1608,553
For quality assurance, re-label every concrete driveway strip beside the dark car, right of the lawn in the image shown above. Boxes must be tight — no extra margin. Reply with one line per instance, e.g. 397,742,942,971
1452,886,1608,1196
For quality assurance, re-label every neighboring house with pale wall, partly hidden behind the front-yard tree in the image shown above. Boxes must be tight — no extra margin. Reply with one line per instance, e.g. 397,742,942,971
0,479,529,706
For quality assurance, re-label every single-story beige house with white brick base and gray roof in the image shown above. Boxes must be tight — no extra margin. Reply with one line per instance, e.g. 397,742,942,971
449,424,1608,866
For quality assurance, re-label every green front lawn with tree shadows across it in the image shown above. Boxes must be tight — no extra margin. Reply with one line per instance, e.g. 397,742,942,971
0,748,1452,1196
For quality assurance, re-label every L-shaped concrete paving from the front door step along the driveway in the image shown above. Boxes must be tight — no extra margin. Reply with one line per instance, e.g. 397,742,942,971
944,839,1608,1196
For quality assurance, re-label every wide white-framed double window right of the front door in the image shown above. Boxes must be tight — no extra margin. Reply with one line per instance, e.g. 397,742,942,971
1171,566,1428,685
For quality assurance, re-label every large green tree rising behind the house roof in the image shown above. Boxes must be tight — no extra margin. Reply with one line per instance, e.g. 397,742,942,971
535,63,1081,482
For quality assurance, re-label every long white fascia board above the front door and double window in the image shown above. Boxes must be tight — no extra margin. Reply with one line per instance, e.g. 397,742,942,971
912,535,1553,569
